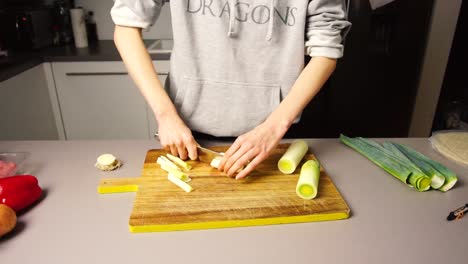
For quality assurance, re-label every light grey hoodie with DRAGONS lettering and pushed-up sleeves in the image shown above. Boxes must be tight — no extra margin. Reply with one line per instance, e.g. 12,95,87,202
111,0,350,136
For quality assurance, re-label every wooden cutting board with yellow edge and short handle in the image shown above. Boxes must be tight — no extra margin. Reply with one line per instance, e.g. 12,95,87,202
98,144,350,232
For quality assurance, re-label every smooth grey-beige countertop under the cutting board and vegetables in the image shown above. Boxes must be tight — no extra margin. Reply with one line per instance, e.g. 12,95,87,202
0,139,468,264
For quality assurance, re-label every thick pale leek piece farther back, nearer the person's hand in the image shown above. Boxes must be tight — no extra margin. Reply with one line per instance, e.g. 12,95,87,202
278,140,309,174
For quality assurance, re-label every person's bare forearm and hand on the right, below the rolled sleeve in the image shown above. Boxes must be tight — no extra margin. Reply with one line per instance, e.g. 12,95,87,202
219,57,336,179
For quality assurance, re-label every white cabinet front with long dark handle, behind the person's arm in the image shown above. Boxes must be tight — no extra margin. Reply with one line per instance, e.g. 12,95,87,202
52,61,169,140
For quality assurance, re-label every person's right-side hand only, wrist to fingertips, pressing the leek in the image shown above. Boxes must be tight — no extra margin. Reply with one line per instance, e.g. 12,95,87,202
219,120,289,180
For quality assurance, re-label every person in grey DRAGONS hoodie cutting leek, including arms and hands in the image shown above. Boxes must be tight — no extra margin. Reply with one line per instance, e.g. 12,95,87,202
111,0,350,179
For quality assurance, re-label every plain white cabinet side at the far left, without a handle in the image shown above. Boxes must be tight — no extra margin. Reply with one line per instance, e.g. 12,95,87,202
0,64,59,140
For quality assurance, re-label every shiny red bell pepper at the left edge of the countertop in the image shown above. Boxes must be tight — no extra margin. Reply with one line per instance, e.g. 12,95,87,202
0,175,42,212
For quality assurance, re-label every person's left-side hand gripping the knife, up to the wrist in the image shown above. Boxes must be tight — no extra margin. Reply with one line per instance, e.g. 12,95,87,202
158,112,198,160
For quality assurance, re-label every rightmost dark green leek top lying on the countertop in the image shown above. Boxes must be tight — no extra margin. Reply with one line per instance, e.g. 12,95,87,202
395,144,458,192
